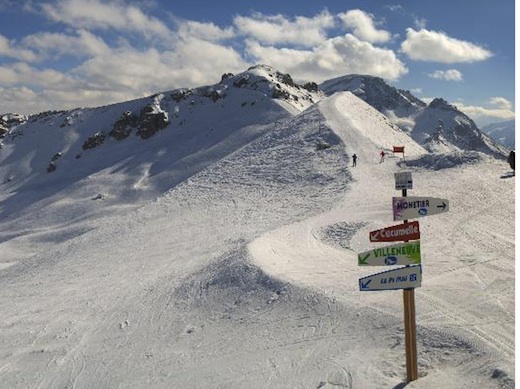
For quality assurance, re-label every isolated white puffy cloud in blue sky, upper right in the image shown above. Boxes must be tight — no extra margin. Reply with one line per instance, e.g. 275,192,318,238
401,28,493,63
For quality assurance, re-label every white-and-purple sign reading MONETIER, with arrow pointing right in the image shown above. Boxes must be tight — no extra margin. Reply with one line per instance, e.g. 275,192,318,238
392,197,449,220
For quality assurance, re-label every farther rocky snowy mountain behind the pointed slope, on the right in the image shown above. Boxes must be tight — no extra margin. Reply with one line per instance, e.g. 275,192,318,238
319,75,508,158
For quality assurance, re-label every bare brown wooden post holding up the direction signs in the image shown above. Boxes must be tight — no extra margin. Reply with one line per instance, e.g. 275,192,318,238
403,189,419,382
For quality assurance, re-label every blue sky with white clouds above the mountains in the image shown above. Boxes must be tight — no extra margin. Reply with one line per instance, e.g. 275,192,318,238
0,0,515,125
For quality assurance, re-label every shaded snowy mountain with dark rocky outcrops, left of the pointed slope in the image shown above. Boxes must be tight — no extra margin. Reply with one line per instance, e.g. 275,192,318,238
0,66,322,221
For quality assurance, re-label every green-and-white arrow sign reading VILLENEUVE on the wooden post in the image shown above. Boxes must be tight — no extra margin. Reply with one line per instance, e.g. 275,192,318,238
358,240,421,266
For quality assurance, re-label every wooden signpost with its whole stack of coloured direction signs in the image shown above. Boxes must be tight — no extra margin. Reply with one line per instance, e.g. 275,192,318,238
358,171,449,382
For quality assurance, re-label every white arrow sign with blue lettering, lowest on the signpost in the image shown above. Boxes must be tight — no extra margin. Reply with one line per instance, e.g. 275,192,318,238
359,265,422,292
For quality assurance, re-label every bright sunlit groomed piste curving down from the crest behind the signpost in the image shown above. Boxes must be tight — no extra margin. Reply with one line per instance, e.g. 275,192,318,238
249,93,514,388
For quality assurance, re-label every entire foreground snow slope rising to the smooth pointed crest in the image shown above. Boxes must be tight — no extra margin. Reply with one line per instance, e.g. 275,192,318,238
0,93,514,389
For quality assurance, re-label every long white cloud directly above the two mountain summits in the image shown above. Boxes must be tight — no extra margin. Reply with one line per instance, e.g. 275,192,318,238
246,34,408,82
